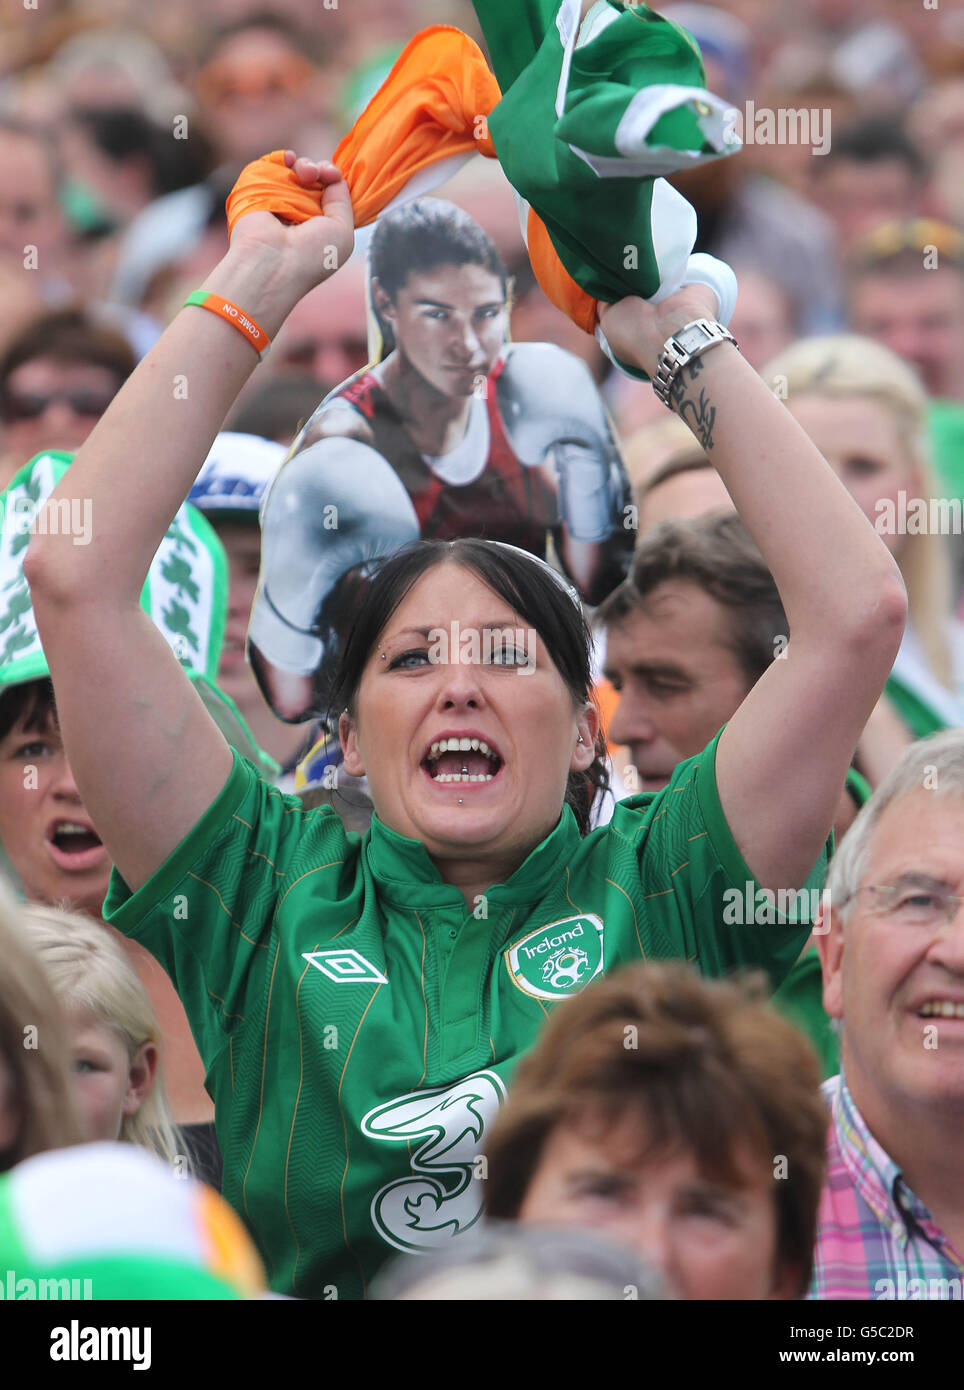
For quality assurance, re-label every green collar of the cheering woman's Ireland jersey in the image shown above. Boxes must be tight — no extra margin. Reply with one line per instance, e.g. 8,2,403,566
365,805,581,909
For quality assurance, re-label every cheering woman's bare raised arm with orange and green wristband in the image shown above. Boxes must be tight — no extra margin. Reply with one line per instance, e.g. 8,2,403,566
25,153,354,888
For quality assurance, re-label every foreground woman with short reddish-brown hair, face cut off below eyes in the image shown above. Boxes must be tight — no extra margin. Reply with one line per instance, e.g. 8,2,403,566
485,962,826,1298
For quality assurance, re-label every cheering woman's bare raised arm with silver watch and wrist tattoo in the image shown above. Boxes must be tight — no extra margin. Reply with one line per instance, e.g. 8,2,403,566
600,286,907,890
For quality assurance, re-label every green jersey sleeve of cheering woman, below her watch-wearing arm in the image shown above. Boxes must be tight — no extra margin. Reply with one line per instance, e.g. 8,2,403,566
614,730,831,988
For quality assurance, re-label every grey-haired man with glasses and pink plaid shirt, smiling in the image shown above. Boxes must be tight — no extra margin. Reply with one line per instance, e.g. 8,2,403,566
810,728,964,1300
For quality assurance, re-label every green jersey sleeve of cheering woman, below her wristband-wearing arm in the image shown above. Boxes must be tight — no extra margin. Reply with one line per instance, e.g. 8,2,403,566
104,753,343,1069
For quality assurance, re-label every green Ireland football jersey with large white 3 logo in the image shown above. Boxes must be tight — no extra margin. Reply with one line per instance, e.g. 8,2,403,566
104,739,826,1298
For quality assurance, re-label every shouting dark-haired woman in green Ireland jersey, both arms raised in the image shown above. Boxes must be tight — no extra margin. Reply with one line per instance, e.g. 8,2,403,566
28,153,906,1298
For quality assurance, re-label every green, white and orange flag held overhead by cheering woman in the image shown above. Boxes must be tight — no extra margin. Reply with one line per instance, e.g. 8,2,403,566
228,0,740,375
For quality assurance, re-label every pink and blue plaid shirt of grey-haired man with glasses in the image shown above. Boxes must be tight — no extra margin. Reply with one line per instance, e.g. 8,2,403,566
807,1074,964,1300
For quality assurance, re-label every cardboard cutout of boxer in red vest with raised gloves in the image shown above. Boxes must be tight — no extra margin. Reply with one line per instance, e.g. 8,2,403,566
249,197,635,723
